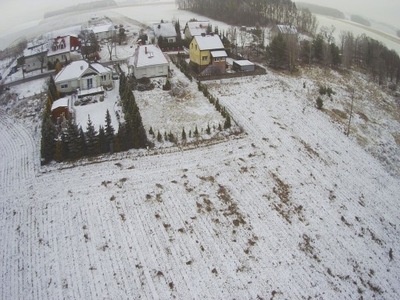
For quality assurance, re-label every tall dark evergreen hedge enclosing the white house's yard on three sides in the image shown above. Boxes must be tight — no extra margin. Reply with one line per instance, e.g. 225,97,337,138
41,74,147,164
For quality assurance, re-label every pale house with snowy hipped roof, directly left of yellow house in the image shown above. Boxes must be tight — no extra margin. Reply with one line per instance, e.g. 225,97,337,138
129,45,169,79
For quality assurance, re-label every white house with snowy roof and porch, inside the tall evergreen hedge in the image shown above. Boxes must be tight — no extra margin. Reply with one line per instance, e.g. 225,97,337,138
54,60,113,98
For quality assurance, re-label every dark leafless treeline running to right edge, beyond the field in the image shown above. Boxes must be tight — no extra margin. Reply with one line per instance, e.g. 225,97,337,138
267,28,400,84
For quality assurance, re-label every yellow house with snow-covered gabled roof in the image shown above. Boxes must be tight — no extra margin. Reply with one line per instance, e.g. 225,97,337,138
189,34,228,74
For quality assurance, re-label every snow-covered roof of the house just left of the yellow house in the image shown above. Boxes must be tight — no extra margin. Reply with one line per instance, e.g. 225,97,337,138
130,45,168,68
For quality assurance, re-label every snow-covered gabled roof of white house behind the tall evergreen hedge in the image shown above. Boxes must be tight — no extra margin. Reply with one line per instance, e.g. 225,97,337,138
54,60,111,82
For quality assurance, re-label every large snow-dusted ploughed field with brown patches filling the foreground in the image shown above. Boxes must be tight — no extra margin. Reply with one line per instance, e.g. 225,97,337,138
0,1,400,299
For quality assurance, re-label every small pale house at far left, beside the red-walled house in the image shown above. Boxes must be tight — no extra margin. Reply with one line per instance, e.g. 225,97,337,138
24,42,48,72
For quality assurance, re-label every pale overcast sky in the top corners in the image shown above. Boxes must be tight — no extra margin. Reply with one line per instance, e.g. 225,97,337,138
0,0,400,36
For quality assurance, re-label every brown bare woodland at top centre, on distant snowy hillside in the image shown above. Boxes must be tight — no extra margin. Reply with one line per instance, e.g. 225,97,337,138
176,0,317,33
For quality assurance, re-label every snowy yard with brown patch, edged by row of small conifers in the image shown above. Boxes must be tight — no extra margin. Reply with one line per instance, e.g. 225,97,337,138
134,64,225,144
